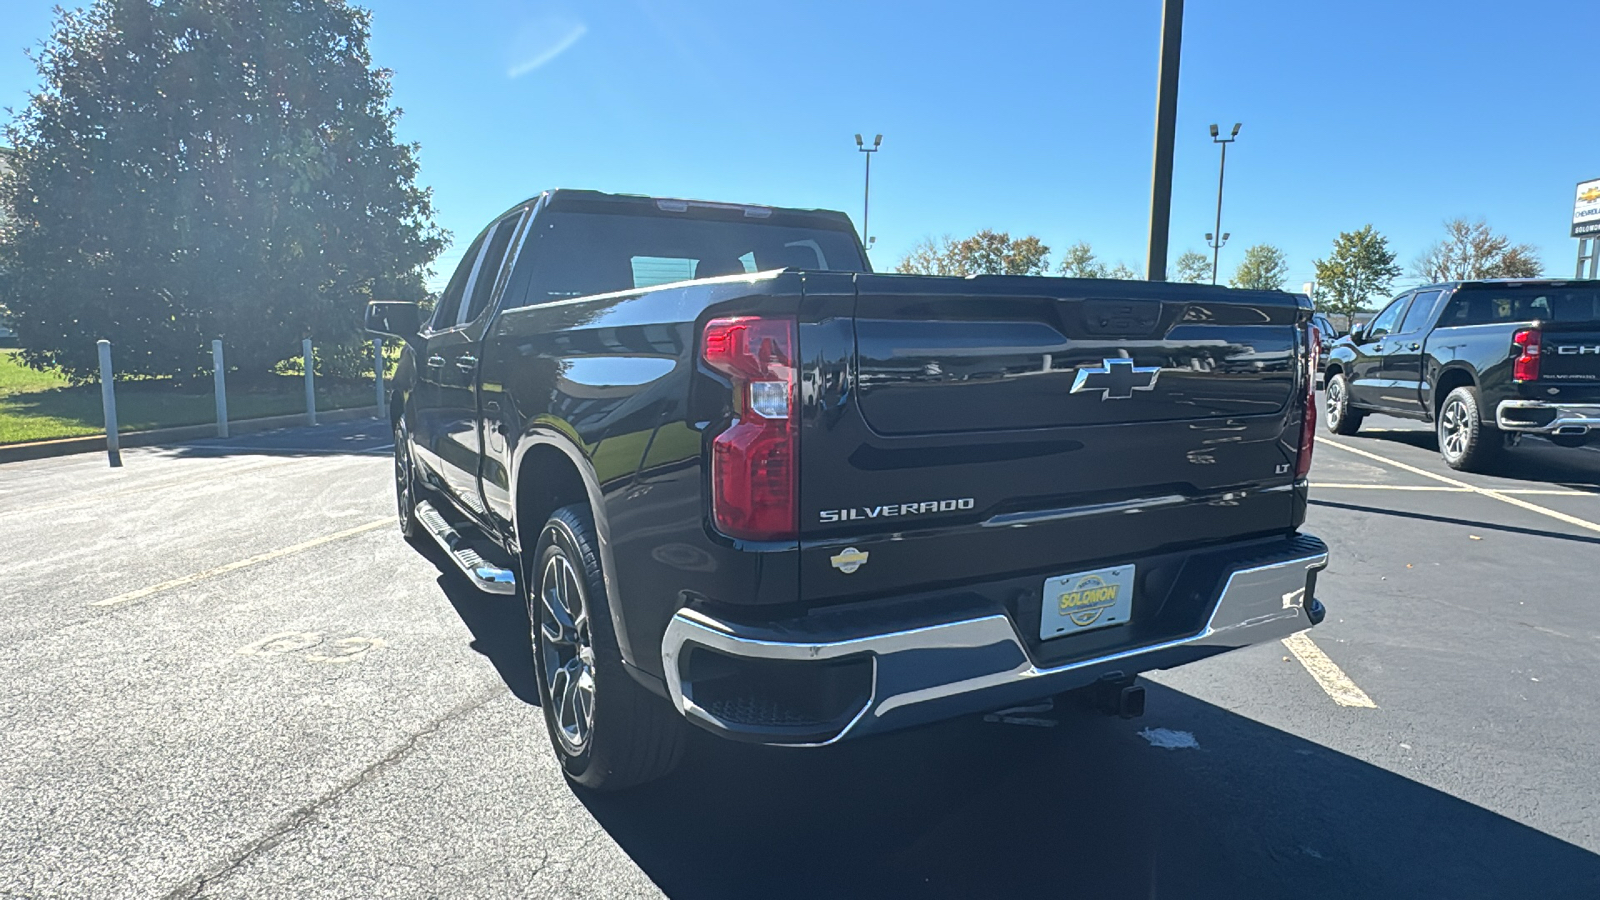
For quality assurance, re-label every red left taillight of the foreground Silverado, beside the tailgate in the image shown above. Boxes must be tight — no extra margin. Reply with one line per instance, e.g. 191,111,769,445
701,315,800,541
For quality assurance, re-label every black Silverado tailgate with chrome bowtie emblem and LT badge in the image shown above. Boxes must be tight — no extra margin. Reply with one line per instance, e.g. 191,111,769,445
800,275,1310,602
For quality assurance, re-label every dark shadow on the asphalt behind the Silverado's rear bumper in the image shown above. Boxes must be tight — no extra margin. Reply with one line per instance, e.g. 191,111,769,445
579,685,1600,900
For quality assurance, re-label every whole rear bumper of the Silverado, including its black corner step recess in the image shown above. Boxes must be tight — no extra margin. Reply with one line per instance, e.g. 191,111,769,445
661,535,1328,746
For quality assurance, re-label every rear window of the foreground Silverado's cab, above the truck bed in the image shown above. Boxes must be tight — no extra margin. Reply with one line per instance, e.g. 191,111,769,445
523,213,866,304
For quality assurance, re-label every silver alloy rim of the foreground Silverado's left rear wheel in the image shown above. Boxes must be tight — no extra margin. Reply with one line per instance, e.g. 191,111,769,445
538,552,595,756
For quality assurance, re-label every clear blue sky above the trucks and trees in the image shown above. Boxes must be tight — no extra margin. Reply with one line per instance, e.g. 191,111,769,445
0,0,1600,287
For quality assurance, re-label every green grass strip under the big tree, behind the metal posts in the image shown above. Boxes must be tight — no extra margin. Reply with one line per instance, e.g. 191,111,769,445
0,349,374,444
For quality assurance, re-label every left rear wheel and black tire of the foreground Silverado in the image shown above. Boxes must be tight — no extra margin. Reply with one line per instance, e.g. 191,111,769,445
523,504,688,791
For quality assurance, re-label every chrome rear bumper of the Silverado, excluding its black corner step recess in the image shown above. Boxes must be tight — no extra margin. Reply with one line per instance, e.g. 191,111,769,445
661,536,1328,746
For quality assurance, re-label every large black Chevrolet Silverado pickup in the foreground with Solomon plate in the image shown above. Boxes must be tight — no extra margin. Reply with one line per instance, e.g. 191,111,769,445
366,191,1328,790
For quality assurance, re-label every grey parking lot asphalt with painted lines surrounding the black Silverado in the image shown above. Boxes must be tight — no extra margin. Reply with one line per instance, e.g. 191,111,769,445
0,416,1600,898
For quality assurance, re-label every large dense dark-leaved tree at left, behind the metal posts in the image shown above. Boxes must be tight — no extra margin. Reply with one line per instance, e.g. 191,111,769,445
0,0,445,378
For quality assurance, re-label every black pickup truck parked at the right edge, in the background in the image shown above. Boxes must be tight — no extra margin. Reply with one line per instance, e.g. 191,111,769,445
1325,280,1600,471
